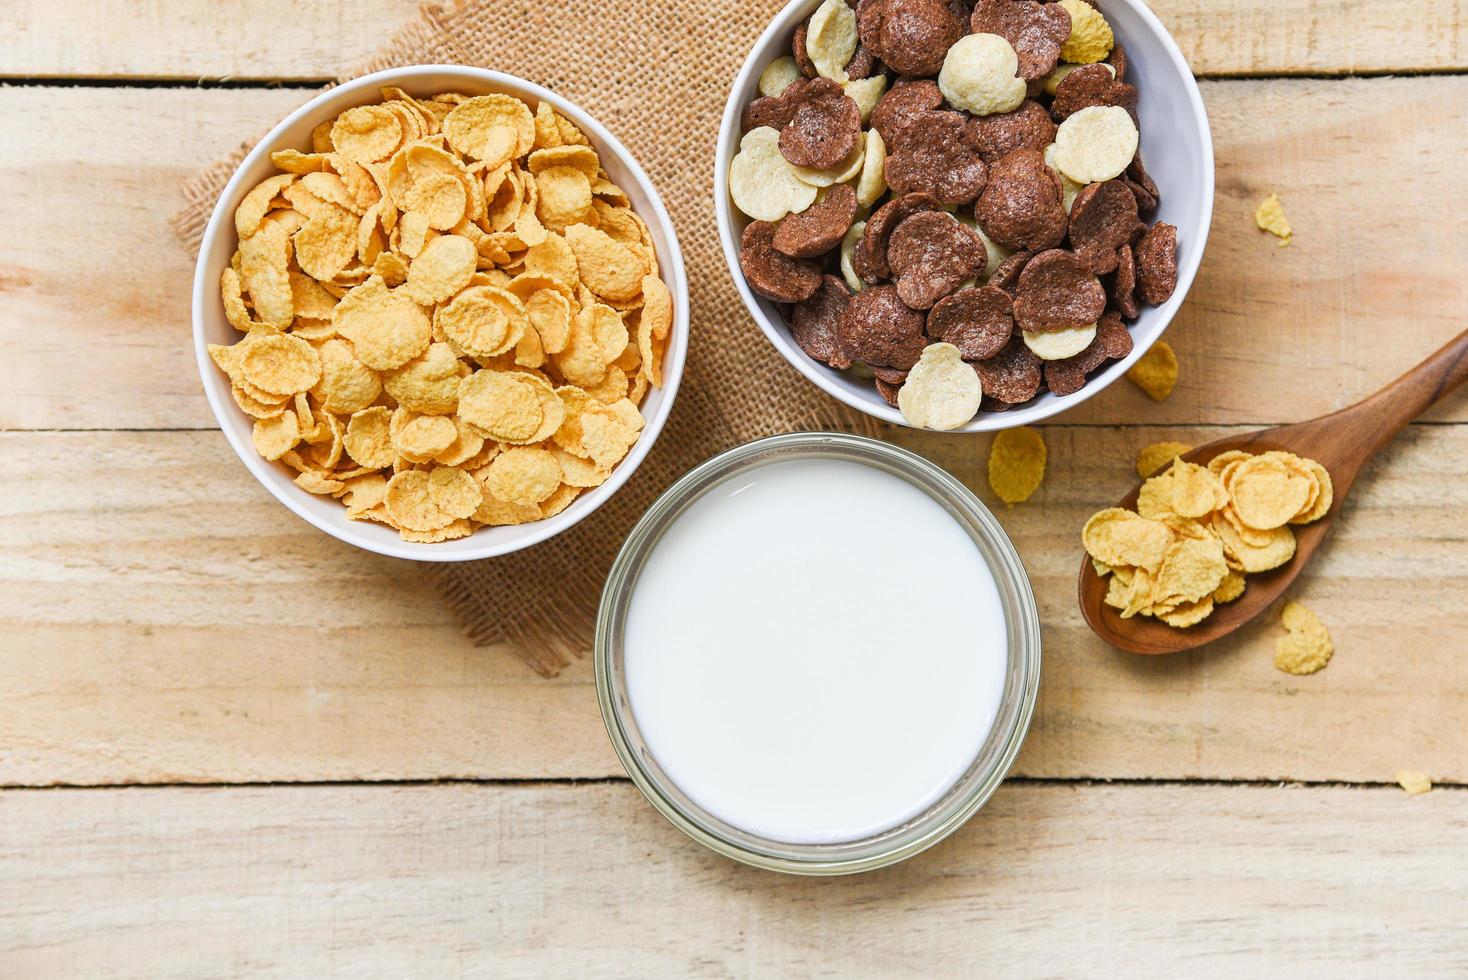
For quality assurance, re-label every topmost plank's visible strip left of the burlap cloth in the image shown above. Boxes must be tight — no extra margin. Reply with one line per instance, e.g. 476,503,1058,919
0,0,418,81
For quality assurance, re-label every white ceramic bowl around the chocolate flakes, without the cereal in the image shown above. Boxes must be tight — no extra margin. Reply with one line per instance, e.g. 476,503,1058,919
713,0,1213,433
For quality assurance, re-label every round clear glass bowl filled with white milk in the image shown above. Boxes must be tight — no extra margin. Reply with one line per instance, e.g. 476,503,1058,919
596,433,1039,874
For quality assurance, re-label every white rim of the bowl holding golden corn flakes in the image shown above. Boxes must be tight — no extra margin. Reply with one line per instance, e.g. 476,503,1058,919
191,65,690,562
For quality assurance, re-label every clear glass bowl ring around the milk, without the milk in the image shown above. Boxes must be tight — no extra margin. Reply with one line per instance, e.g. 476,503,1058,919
596,433,1039,874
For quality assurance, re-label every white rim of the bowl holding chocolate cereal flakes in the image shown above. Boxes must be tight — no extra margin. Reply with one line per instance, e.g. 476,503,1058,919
713,0,1216,433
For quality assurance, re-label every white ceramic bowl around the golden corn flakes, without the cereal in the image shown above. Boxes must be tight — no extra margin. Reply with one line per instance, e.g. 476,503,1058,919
194,65,688,562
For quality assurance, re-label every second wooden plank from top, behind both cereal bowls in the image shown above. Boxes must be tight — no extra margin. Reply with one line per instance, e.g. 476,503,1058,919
0,78,1468,428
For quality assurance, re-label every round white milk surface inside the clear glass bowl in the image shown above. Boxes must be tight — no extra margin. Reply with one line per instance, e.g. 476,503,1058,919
624,459,1007,844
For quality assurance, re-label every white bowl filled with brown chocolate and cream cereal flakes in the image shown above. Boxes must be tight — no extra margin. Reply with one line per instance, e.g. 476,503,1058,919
713,0,1214,431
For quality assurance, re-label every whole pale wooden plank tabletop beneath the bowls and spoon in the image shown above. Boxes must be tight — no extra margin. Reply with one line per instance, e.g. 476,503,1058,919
0,0,1468,977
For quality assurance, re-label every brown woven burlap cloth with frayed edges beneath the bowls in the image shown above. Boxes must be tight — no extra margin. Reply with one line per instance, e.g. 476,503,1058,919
175,0,871,676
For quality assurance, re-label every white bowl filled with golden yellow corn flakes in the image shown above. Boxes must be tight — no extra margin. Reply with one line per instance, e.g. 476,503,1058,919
192,66,688,562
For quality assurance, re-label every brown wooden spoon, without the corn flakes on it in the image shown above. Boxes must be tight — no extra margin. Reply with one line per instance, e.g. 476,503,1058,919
1079,330,1468,654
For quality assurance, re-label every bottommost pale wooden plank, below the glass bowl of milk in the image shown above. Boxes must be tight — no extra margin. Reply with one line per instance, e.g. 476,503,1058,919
0,782,1468,980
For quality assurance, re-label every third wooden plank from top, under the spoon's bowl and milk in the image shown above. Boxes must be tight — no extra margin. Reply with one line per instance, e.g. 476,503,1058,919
0,425,1468,785
